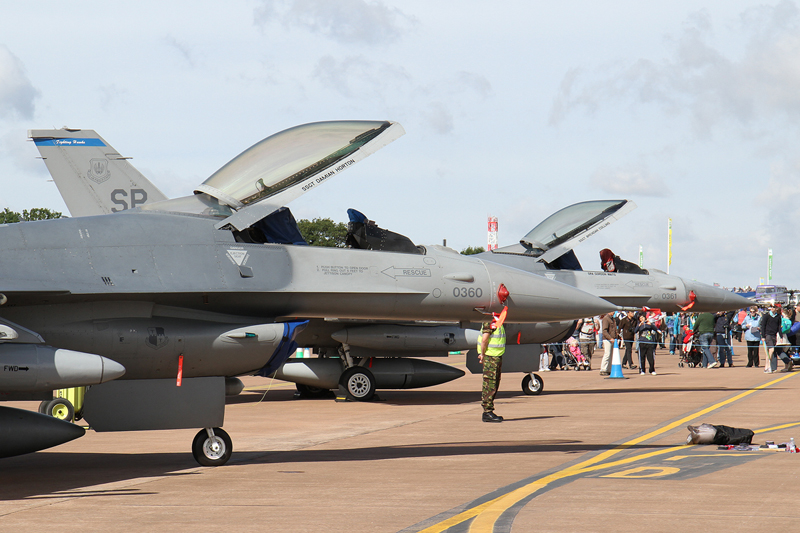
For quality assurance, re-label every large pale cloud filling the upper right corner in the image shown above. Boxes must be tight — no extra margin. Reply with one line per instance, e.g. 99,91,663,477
550,0,800,137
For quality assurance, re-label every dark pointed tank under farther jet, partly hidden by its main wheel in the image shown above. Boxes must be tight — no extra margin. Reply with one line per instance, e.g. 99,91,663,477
275,357,464,389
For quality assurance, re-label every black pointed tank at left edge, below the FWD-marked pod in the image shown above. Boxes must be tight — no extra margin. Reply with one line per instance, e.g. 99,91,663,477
0,407,86,457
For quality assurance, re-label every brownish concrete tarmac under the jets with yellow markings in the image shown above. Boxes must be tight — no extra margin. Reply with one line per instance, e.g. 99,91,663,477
0,346,800,533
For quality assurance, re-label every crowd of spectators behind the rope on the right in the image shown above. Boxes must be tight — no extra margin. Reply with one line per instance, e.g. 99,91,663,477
539,304,800,376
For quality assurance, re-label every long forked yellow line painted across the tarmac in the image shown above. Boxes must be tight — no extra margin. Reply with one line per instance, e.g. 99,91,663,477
420,374,796,533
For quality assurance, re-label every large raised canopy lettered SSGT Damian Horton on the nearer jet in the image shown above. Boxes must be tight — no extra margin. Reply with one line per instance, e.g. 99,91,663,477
195,120,405,230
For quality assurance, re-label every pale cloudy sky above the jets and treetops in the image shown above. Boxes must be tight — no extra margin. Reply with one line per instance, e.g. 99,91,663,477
0,0,800,289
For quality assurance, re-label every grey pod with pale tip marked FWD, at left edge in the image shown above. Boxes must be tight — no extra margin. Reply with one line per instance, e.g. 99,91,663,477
0,343,125,392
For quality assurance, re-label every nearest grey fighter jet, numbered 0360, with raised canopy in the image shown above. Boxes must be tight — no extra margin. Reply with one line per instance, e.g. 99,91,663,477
0,121,615,465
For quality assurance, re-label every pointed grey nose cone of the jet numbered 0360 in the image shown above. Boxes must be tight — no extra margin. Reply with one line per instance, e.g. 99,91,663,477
485,263,617,322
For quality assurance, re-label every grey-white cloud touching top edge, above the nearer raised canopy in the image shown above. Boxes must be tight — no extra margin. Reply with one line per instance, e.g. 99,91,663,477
255,0,416,44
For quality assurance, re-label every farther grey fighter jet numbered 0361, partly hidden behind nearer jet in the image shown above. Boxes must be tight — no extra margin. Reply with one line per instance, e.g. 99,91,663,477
29,129,746,400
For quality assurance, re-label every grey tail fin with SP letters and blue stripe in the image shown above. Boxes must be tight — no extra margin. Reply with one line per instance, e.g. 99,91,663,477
28,128,167,217
